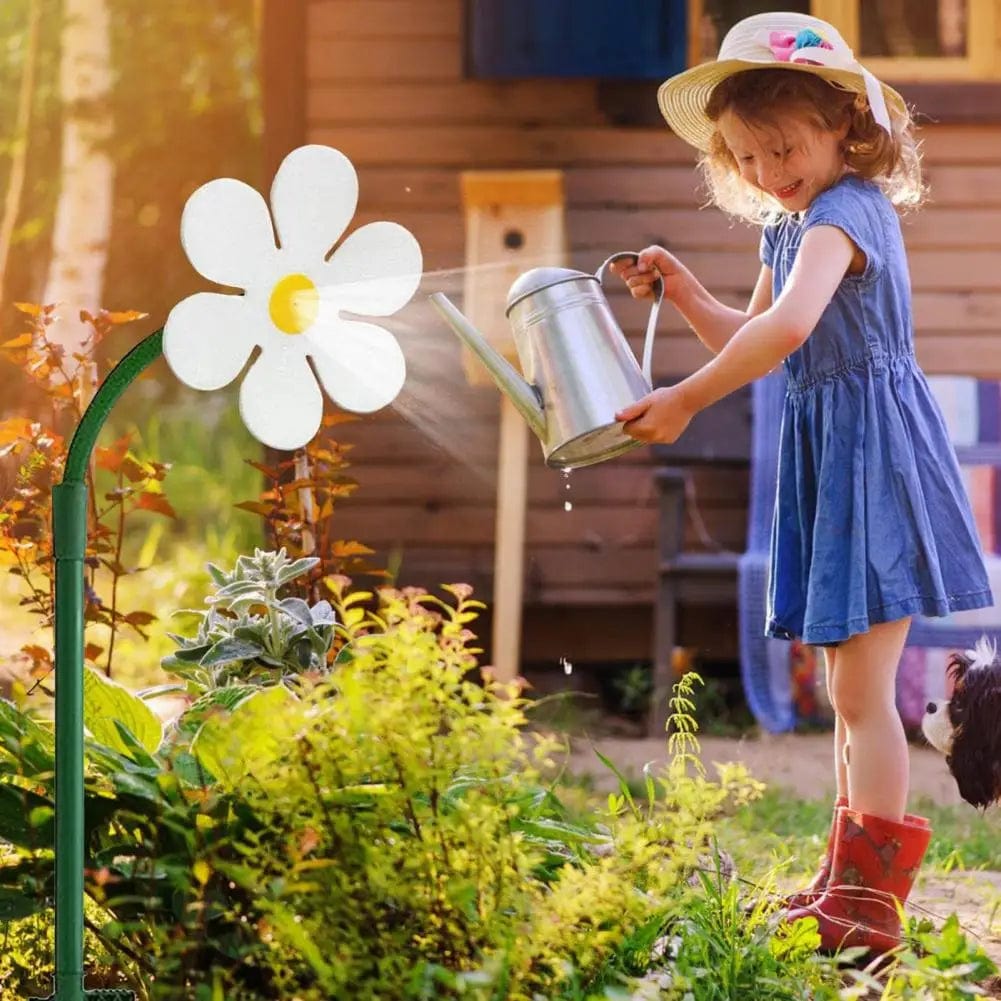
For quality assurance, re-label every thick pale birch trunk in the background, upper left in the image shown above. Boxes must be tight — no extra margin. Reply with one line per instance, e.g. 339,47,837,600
44,0,114,350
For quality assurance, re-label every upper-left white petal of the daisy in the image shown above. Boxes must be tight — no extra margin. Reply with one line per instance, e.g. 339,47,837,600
181,177,278,288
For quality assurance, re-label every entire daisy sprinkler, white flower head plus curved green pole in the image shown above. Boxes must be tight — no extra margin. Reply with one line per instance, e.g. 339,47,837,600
36,145,422,1001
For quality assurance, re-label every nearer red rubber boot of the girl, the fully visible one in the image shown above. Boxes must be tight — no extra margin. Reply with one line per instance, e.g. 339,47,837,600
788,808,932,953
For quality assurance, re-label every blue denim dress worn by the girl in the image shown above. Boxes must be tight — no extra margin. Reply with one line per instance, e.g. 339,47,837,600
761,175,993,645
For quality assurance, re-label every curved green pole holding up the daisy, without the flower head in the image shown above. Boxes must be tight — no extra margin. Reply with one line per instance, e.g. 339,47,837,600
36,328,163,1001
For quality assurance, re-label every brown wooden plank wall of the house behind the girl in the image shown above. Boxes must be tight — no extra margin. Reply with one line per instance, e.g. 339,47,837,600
288,0,1001,659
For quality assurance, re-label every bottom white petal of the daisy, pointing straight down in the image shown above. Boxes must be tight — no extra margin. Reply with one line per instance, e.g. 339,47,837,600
240,348,323,451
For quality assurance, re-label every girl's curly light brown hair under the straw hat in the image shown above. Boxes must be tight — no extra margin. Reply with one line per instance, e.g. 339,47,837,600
699,68,925,225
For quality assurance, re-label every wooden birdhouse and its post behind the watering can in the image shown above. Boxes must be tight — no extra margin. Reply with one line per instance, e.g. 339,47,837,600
461,170,566,682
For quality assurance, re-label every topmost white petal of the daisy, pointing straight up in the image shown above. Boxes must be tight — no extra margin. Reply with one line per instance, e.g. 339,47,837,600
271,145,358,262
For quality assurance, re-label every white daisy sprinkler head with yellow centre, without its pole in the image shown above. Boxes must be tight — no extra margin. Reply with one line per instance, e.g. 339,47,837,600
163,145,422,449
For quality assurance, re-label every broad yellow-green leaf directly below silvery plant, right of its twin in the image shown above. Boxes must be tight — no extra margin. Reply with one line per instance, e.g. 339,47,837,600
191,685,304,784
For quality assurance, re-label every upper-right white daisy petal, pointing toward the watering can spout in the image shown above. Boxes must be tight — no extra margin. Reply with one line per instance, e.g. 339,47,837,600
317,222,423,316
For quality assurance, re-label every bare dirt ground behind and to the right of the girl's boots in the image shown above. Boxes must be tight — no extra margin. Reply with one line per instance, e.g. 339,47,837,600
571,734,1001,968
